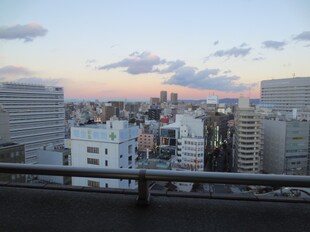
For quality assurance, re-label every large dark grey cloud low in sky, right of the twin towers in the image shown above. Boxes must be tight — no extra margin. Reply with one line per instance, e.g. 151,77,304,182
163,66,253,92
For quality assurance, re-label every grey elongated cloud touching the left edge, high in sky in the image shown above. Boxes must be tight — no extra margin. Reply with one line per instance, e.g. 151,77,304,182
0,23,47,42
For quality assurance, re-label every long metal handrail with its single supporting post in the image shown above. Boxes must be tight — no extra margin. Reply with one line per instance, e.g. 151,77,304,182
0,163,310,204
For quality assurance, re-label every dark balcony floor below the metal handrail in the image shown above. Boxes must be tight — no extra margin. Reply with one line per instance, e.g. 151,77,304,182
0,186,310,232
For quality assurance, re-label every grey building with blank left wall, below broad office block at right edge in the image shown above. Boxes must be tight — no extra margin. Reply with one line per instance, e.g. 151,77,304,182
263,119,310,175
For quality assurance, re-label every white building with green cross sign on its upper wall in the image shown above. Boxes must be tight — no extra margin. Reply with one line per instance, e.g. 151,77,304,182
71,121,138,188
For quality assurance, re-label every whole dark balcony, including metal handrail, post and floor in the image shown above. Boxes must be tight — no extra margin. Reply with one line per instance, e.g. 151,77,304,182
0,164,310,231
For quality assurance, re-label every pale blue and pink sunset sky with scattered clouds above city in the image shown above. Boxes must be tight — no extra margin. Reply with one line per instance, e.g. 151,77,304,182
0,0,310,99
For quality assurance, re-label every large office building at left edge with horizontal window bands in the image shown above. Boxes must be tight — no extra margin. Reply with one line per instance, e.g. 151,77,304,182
0,83,65,163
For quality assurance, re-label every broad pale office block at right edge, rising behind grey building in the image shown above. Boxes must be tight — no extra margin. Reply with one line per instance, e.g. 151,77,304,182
261,77,310,113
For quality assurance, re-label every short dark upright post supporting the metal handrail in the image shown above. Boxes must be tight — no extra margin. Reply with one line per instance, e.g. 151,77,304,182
137,170,151,206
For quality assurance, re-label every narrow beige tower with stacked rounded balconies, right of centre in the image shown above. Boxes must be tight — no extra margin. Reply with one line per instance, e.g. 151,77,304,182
233,98,261,173
